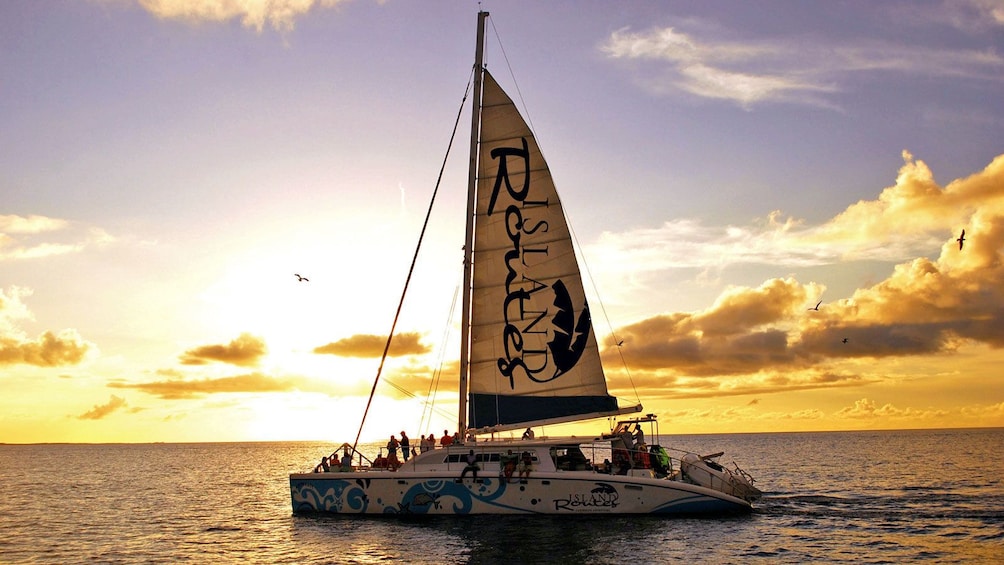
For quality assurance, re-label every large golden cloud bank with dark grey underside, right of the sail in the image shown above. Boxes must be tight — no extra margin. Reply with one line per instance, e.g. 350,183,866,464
606,154,1004,397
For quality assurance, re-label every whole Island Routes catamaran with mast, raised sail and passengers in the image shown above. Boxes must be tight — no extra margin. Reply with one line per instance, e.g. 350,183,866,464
289,12,760,515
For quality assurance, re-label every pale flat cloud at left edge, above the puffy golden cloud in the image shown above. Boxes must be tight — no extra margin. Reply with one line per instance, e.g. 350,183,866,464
0,216,114,262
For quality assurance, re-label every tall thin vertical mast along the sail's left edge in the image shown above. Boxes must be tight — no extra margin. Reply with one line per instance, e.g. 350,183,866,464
457,11,488,438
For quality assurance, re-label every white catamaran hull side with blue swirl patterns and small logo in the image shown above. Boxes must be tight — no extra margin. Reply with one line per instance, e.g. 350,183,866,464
289,472,751,515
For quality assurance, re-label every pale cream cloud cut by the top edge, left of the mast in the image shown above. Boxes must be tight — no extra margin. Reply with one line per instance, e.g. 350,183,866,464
139,0,345,33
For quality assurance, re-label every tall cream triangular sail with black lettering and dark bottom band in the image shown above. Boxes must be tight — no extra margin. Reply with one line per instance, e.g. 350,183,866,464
468,71,641,429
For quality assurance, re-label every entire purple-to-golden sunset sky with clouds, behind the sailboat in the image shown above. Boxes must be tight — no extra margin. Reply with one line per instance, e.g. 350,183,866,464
0,0,1004,443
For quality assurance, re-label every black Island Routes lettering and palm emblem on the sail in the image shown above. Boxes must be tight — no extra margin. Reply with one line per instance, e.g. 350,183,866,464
488,137,591,388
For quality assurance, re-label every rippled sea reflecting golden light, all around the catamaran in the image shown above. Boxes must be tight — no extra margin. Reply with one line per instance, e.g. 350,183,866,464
0,429,1004,564
